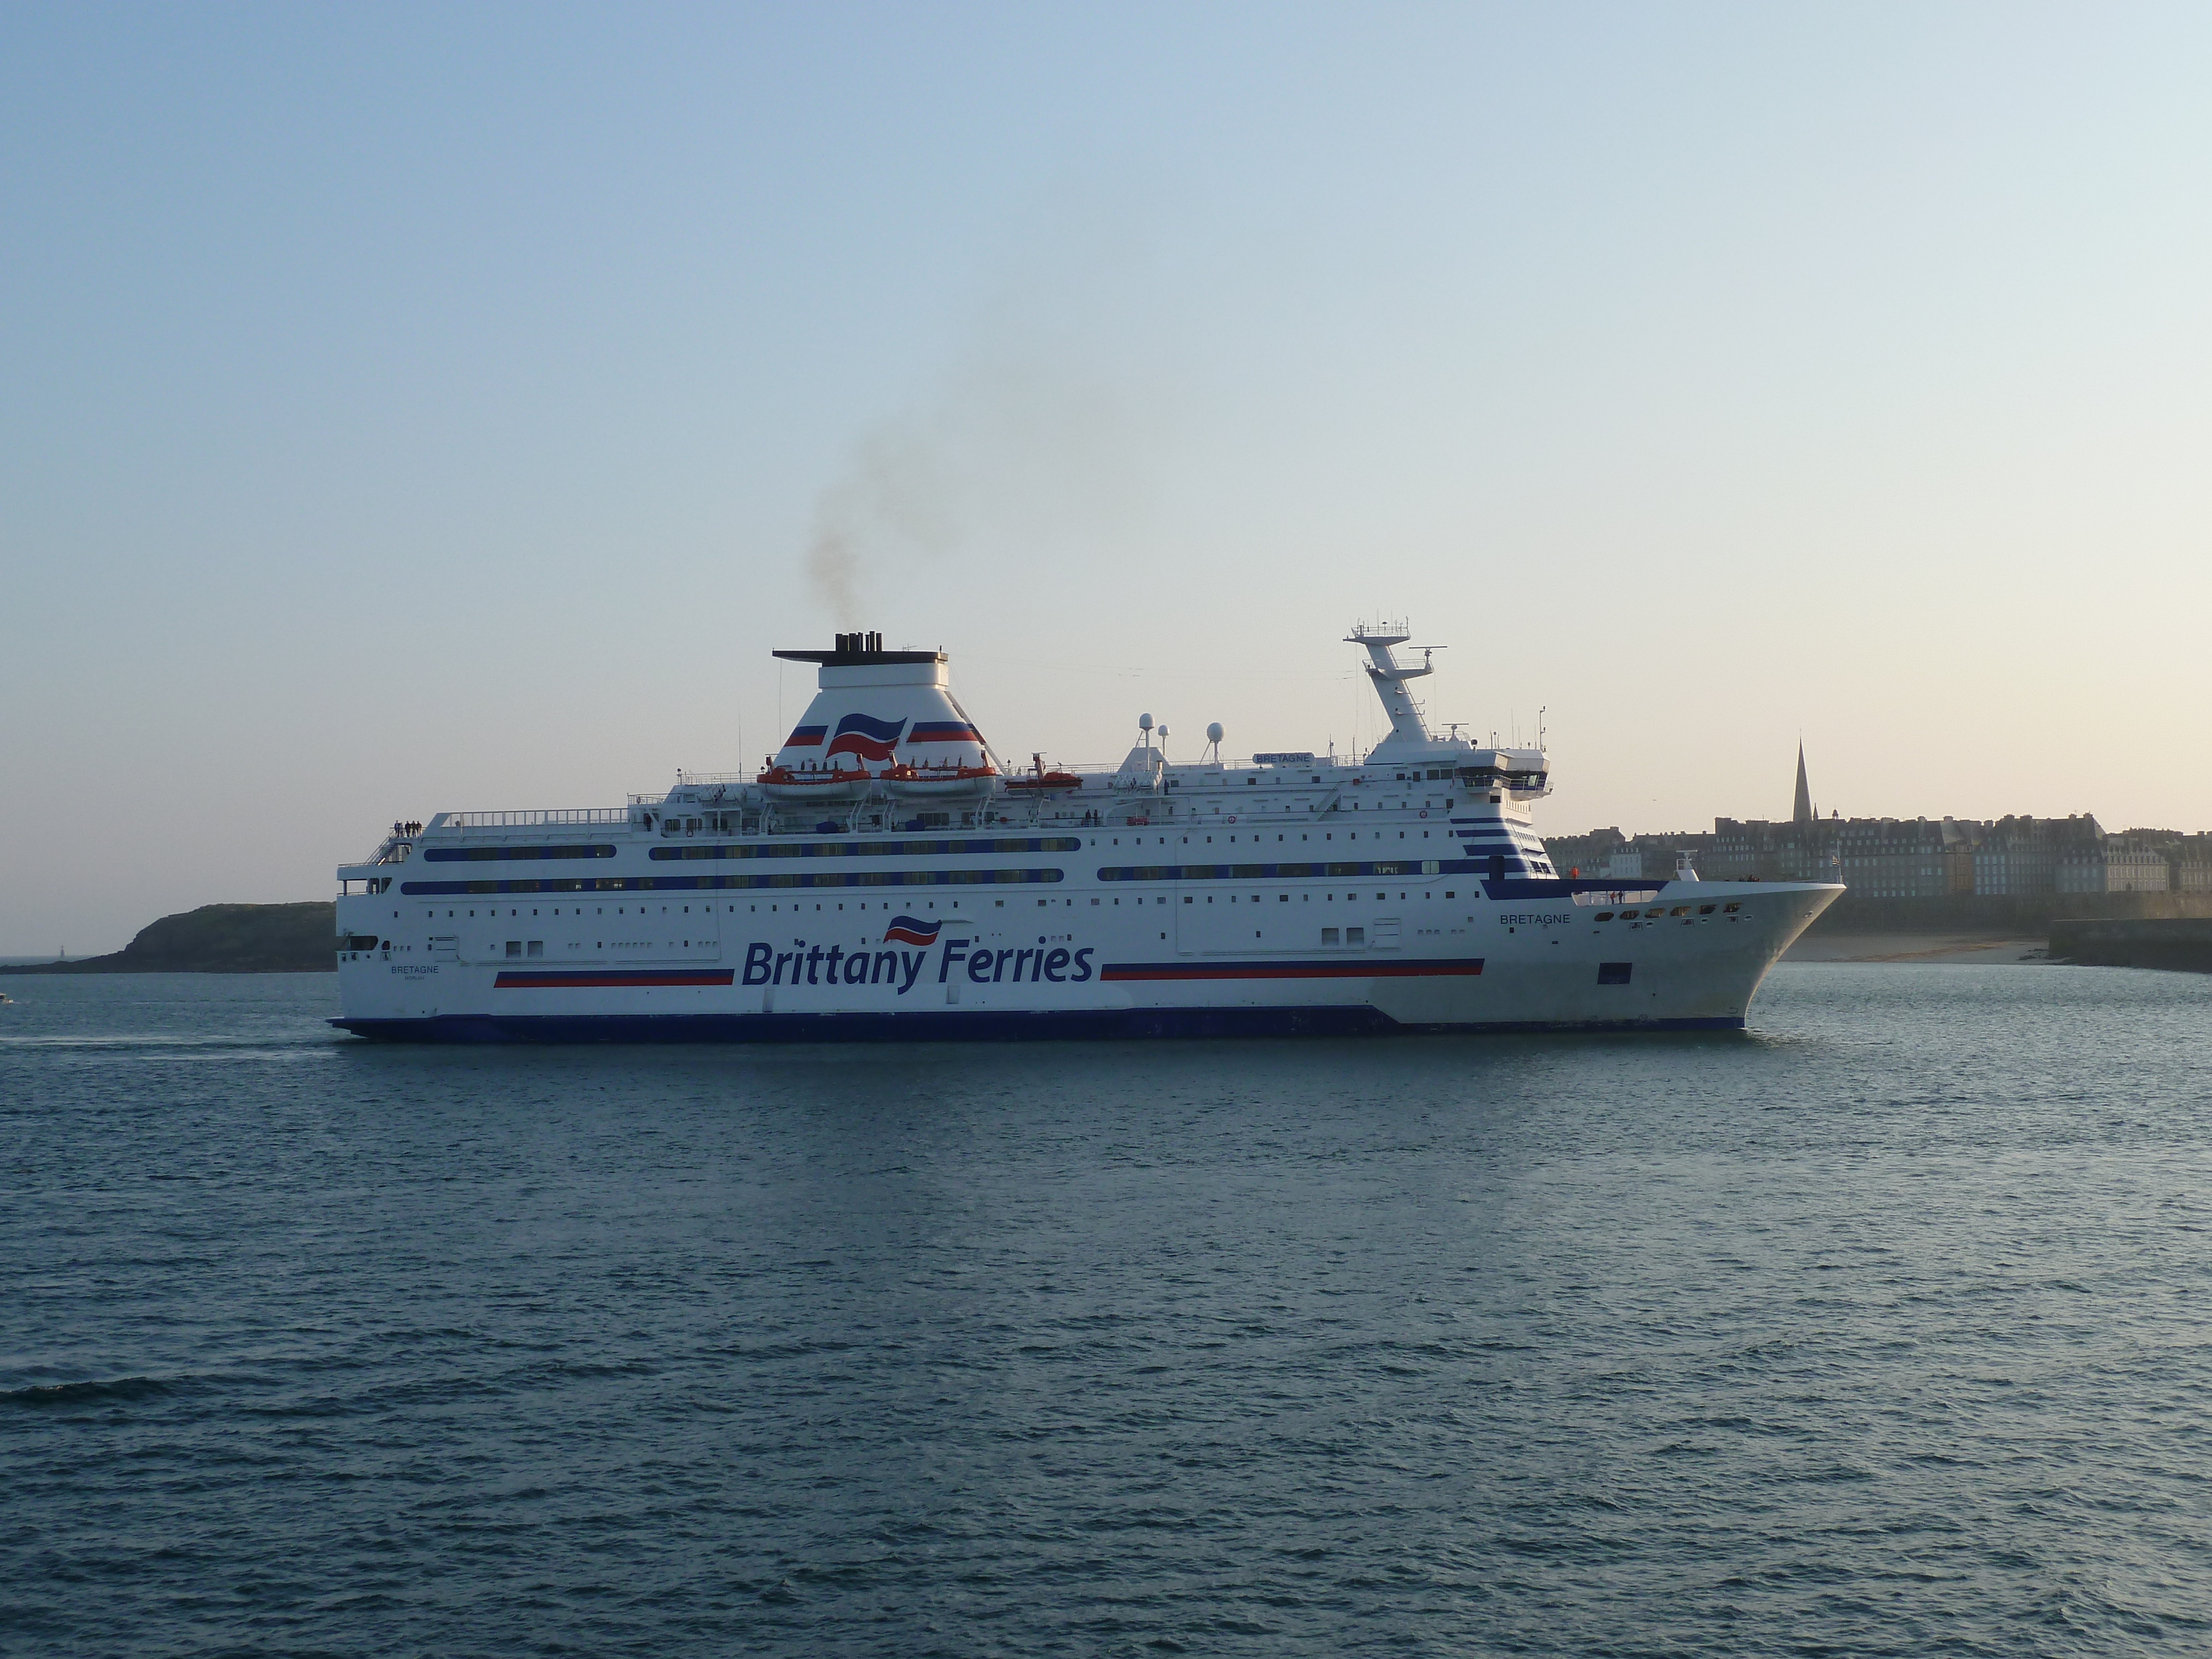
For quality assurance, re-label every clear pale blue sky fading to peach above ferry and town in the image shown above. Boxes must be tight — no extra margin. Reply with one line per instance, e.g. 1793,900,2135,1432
0,2,2212,953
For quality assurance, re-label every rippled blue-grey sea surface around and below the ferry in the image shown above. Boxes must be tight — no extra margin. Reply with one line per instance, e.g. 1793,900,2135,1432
0,964,2212,1655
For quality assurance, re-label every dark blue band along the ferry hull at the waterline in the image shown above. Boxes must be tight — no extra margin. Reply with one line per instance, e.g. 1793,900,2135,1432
332,1004,1743,1042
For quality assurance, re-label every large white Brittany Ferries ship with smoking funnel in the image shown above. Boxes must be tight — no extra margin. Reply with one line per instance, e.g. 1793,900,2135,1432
334,628,1843,1042
